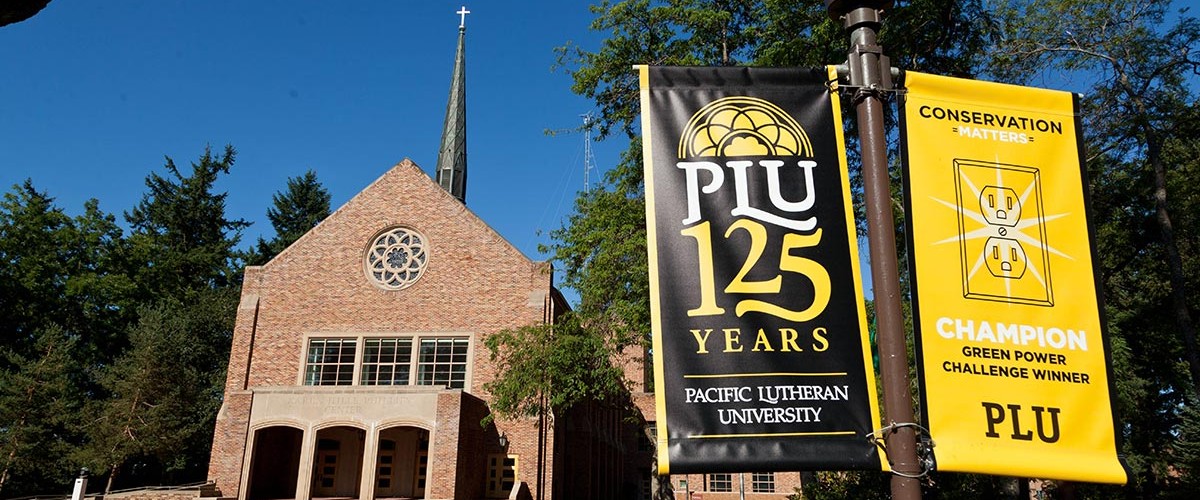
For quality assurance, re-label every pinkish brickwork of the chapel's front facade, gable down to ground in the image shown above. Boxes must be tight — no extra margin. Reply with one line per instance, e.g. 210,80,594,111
209,159,552,499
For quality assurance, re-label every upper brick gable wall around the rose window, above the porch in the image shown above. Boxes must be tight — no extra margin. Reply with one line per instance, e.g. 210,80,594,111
235,161,551,394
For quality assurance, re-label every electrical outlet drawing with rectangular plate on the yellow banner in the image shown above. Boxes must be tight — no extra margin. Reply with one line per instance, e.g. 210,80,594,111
954,158,1054,306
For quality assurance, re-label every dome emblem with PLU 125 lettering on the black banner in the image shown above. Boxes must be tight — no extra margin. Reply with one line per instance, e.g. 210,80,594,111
676,96,832,321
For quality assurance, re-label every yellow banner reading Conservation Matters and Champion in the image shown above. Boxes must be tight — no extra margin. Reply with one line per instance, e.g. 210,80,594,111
901,72,1126,483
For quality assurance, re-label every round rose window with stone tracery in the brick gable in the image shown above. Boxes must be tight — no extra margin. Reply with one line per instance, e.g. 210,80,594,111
366,228,428,290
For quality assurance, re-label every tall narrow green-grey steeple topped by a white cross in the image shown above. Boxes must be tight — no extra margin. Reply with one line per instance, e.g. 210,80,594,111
437,6,470,204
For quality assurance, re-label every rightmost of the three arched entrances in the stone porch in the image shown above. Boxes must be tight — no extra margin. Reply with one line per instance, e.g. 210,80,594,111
372,427,430,499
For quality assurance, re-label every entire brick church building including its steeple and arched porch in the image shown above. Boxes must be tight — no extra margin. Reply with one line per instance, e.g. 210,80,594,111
209,10,799,500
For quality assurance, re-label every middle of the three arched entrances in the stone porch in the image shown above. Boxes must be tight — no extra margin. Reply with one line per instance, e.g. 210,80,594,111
311,426,367,499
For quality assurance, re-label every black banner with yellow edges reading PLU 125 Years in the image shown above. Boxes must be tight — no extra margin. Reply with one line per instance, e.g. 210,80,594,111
638,67,883,474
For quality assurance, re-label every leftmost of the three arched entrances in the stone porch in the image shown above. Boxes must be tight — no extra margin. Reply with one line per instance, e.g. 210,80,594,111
247,426,304,500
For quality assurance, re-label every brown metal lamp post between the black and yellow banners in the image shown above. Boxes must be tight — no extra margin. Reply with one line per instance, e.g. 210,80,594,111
826,0,922,500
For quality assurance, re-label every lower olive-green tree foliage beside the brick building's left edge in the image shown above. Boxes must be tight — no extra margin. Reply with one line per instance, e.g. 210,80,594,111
83,289,236,486
